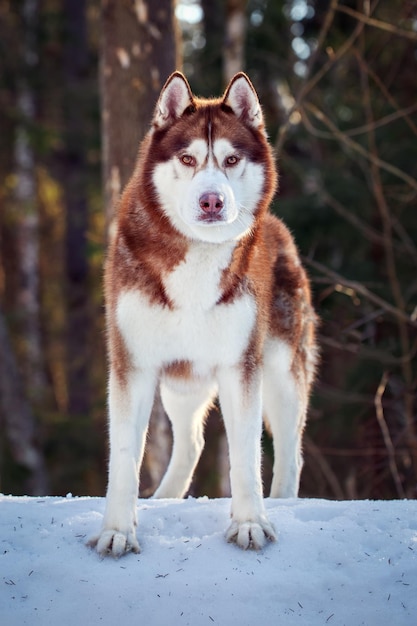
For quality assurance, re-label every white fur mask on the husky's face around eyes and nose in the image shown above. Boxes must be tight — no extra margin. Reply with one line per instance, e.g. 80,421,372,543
153,139,263,243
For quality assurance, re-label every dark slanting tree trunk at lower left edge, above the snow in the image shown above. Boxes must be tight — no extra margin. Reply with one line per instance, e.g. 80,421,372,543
0,309,48,495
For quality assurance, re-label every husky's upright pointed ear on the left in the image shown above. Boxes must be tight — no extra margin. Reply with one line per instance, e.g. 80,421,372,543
153,72,194,128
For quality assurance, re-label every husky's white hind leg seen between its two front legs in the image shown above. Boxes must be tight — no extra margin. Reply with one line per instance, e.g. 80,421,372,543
154,383,217,498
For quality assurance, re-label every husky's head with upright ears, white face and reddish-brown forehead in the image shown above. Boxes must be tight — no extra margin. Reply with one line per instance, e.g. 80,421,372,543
140,72,276,243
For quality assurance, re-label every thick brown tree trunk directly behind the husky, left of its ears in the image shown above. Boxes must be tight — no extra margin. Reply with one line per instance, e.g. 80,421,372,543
101,0,180,495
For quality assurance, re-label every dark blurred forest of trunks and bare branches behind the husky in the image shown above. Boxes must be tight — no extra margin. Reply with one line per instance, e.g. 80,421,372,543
0,0,417,499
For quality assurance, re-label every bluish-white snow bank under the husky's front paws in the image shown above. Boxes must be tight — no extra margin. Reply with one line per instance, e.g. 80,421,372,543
0,496,417,626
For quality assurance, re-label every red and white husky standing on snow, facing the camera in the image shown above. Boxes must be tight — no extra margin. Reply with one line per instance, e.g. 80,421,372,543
91,72,316,556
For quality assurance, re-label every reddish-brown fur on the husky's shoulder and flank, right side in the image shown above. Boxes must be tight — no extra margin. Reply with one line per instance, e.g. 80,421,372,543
220,214,315,381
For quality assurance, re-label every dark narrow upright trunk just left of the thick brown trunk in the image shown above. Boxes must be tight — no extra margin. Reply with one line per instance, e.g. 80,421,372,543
62,0,91,415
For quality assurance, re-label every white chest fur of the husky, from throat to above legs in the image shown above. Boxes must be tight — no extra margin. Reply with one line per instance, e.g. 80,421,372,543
117,244,256,370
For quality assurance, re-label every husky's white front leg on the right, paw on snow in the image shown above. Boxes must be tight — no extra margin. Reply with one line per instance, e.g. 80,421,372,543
219,368,276,550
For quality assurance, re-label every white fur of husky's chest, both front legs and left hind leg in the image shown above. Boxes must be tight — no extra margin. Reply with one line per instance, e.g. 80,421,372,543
92,234,275,557
